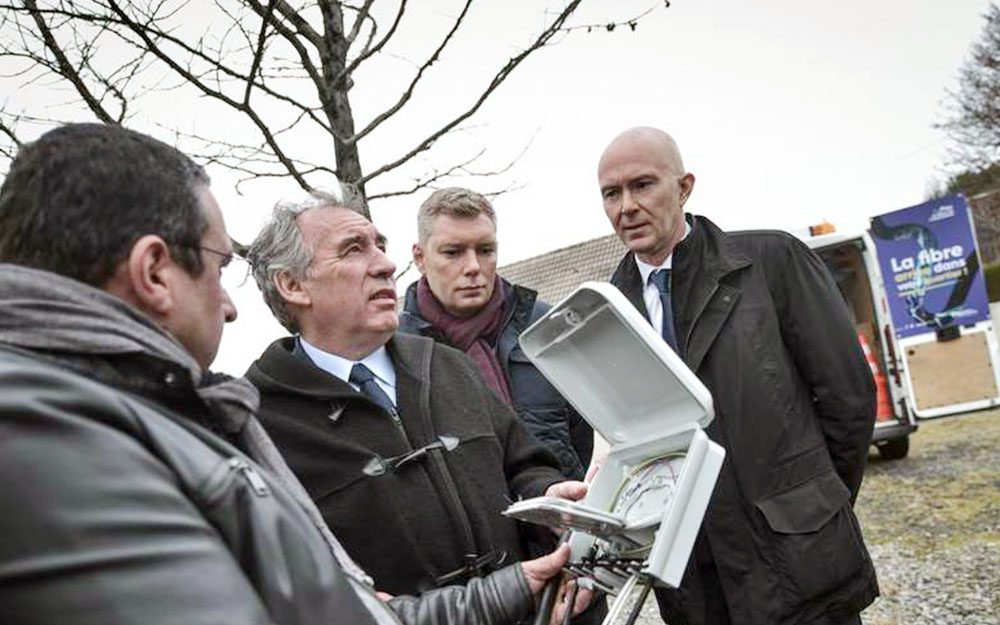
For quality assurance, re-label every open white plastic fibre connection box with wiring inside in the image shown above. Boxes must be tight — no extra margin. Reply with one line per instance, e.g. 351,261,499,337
504,282,725,593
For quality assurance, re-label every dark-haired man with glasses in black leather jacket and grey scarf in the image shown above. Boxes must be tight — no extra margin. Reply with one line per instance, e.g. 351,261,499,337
0,124,584,625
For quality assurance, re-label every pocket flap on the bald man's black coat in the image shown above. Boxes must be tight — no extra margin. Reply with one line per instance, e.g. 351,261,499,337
757,471,851,534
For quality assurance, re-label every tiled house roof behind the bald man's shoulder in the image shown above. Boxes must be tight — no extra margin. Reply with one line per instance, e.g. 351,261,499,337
497,234,627,304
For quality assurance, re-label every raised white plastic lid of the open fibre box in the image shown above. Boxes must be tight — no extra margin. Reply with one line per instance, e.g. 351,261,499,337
519,282,713,446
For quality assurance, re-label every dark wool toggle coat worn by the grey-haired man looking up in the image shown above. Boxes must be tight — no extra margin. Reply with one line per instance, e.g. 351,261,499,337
247,334,564,594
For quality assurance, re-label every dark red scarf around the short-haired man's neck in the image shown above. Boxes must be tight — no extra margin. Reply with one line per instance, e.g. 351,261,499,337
417,276,513,404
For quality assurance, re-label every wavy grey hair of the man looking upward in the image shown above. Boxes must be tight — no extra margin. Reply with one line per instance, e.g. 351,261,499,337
247,185,363,334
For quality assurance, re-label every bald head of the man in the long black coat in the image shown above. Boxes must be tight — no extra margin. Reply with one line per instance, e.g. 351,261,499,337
597,127,694,265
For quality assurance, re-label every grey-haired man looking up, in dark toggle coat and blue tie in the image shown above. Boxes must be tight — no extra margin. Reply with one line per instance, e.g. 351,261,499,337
247,194,586,593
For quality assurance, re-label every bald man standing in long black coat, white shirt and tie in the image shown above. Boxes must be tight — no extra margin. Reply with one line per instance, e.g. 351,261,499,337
598,128,878,625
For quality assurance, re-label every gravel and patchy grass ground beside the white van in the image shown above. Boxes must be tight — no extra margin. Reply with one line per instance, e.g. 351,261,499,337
622,410,1000,625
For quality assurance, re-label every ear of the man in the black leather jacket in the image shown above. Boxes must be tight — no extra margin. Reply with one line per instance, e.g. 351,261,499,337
105,234,184,321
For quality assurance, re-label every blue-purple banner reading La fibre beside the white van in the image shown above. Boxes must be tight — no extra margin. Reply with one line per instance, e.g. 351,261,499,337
870,195,990,338
